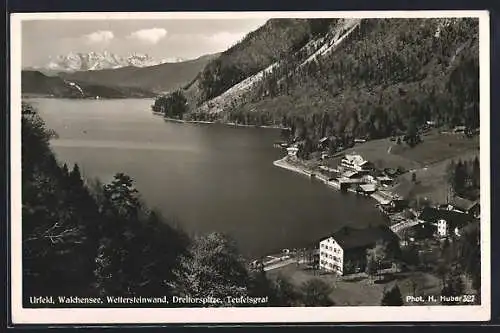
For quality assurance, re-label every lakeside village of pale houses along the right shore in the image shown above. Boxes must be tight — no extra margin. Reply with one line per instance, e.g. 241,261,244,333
254,127,480,300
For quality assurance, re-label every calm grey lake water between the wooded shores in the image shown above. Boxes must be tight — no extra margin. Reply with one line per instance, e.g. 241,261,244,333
26,99,384,257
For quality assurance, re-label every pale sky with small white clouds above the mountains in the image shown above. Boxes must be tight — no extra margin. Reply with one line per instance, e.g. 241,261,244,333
21,18,267,67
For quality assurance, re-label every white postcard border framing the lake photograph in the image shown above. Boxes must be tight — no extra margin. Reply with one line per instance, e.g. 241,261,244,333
10,11,491,324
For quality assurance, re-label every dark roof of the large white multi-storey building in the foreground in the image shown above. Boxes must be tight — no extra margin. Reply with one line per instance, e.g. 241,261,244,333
327,225,397,250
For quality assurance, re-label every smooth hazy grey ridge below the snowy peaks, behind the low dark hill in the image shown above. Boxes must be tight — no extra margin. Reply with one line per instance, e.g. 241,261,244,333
59,54,217,93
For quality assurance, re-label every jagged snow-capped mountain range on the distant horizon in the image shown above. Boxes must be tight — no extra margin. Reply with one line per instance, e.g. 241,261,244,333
28,51,185,72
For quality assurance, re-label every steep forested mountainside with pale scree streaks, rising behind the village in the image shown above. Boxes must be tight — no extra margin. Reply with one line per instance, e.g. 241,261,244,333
173,18,479,154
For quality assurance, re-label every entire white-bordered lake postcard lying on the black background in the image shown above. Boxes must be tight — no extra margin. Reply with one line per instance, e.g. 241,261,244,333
10,11,490,324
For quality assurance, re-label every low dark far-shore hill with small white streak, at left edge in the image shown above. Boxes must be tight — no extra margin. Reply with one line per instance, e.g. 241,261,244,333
21,71,154,98
